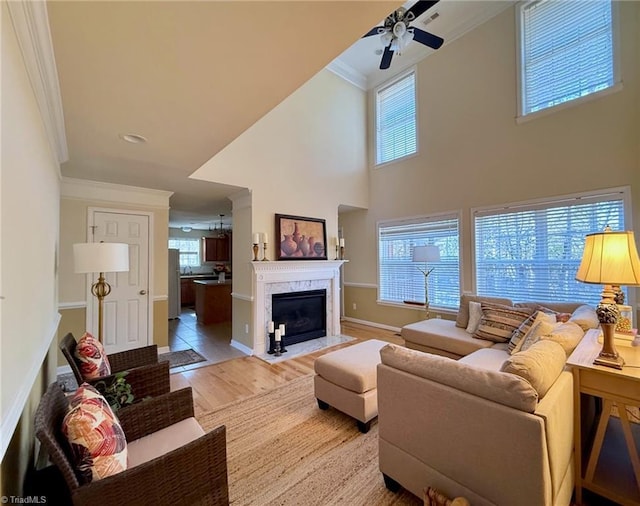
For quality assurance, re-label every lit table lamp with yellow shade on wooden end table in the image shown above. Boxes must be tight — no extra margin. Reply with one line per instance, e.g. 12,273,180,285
576,227,640,369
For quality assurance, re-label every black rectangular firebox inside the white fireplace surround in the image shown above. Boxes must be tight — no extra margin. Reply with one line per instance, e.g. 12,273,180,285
271,290,327,346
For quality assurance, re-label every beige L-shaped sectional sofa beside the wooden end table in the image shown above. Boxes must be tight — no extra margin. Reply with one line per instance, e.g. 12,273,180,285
377,296,597,506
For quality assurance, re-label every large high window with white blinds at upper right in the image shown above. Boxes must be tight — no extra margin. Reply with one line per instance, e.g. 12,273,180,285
519,0,615,116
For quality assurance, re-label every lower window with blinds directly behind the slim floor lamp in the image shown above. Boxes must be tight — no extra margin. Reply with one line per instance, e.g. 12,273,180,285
378,214,460,309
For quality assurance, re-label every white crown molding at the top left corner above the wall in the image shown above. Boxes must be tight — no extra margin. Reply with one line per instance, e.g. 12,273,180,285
6,1,69,164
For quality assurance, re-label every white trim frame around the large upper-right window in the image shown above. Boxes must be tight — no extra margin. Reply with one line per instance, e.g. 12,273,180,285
515,0,626,123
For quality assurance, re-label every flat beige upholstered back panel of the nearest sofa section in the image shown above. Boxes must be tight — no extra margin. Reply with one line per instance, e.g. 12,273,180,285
378,361,552,506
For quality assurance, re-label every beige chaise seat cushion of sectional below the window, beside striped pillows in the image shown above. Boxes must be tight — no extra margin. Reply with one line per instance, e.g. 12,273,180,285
401,318,494,357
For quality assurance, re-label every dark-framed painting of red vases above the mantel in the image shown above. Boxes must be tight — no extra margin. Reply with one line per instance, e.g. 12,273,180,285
276,214,327,260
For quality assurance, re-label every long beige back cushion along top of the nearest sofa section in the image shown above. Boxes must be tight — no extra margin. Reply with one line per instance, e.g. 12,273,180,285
380,344,538,413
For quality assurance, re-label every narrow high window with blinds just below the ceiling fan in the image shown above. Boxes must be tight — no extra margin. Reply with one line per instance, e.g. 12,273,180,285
376,71,417,165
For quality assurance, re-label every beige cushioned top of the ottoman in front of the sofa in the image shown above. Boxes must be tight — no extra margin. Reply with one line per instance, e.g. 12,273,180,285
314,339,387,394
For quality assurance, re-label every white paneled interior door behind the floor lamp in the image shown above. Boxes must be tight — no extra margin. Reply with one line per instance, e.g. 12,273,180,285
87,211,151,353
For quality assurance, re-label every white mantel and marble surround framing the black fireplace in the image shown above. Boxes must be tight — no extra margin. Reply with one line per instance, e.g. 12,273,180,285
251,260,344,356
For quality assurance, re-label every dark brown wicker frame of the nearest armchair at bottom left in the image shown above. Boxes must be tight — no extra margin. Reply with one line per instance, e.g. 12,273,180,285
35,383,229,506
